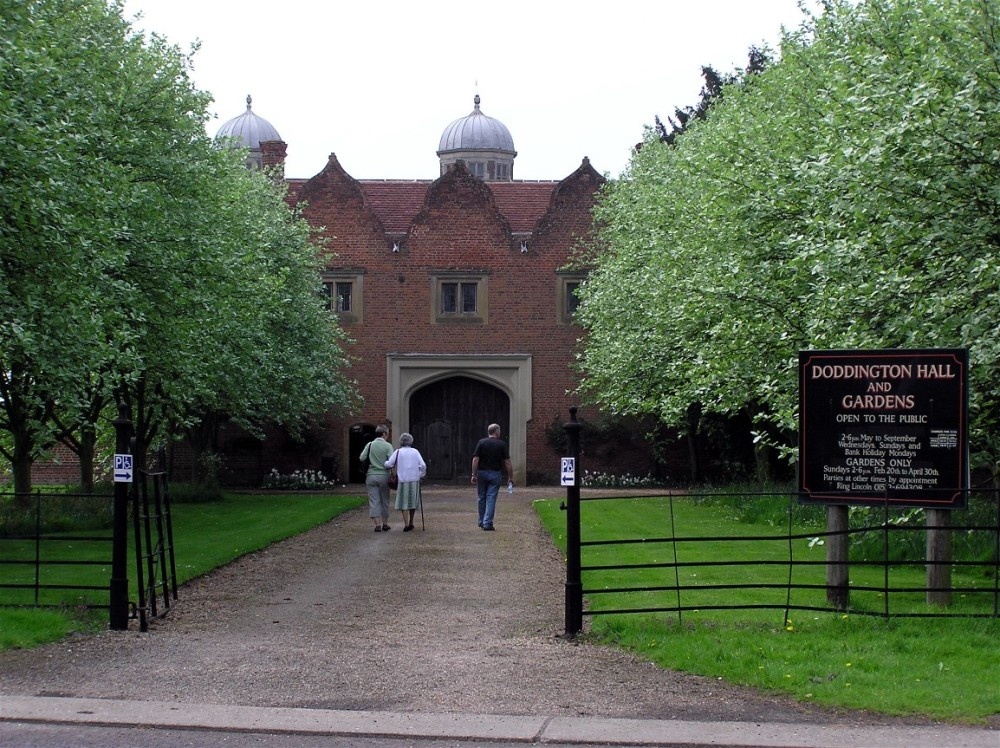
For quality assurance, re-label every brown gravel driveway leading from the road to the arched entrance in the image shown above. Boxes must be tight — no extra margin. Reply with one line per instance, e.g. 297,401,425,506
0,486,964,724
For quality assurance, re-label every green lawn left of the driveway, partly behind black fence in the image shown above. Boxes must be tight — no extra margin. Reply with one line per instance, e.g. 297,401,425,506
0,492,365,649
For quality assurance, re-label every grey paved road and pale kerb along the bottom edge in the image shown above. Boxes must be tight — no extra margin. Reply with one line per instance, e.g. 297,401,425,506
0,696,1000,748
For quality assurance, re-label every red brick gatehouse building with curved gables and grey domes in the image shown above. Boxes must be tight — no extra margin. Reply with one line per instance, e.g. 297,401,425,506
154,95,664,485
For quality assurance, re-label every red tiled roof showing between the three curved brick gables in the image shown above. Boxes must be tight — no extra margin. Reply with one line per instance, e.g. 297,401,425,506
360,180,559,234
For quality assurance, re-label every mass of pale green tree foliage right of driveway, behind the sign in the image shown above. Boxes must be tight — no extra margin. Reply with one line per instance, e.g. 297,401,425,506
578,0,1000,462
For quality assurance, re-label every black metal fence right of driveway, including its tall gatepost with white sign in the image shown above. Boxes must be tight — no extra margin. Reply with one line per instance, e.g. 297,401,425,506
561,408,1000,637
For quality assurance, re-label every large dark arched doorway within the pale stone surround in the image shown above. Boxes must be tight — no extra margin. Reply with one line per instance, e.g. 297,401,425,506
410,376,510,481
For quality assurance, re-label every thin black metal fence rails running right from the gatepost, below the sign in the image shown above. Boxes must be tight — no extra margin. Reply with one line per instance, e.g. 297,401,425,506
567,490,1000,630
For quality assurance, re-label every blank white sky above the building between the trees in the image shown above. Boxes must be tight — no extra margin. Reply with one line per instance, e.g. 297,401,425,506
124,0,814,179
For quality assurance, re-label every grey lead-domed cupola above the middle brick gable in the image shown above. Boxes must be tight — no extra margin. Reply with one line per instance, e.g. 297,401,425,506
437,94,517,182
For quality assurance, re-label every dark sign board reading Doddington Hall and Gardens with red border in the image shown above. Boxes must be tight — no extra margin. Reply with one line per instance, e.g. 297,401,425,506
799,349,969,509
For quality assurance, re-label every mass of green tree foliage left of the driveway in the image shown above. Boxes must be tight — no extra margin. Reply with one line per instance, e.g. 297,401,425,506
0,0,354,490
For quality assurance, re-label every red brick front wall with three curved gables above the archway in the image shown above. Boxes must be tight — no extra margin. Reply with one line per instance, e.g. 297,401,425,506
298,159,603,480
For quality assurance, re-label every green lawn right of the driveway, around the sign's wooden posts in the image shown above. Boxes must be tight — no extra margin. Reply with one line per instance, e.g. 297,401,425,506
536,499,1000,722
